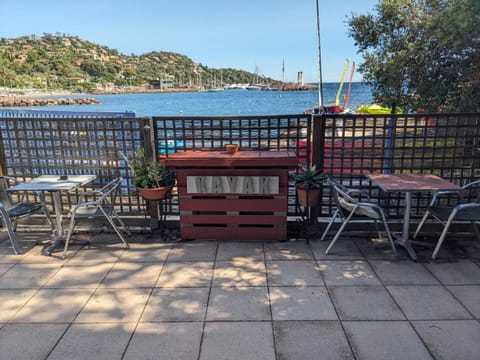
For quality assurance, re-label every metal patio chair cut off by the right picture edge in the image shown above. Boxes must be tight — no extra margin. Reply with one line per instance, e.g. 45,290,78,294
413,180,480,259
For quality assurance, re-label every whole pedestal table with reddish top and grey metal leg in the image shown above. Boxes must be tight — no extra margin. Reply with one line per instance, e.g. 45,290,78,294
365,174,462,260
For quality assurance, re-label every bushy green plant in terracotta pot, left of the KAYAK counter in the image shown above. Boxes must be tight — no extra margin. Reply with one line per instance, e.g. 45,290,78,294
130,149,175,200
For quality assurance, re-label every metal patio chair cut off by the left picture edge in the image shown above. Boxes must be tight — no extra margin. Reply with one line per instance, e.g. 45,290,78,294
0,176,55,255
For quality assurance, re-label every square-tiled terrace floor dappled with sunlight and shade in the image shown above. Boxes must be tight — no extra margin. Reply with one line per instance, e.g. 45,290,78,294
0,233,480,360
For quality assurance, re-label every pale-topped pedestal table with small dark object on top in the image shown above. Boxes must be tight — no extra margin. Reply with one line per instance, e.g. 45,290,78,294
9,175,97,255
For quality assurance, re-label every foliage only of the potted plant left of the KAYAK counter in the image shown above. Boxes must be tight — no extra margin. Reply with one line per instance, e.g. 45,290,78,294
130,149,175,189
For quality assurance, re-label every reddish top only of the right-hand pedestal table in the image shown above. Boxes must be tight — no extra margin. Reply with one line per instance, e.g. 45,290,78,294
365,174,462,192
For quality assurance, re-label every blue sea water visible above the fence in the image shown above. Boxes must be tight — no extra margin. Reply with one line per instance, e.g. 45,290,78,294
10,82,372,117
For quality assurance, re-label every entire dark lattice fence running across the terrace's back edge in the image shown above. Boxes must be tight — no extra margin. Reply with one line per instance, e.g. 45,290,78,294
0,114,480,217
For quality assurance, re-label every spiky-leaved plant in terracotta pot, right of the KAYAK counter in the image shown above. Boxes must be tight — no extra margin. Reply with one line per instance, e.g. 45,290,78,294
290,165,327,207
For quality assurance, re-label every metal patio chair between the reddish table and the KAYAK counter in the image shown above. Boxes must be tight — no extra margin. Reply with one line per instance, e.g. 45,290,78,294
321,179,397,255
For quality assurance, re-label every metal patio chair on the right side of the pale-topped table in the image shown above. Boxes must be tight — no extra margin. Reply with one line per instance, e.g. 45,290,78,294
63,177,131,258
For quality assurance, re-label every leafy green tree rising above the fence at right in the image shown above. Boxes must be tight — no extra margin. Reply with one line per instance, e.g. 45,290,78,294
347,0,480,112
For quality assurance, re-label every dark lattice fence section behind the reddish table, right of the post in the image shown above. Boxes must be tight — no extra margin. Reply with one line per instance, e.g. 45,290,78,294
313,114,480,217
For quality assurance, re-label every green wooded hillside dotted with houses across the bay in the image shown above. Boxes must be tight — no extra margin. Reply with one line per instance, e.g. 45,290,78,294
0,34,278,91
